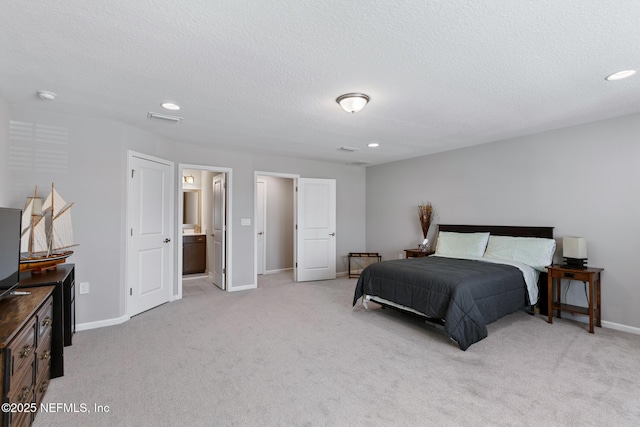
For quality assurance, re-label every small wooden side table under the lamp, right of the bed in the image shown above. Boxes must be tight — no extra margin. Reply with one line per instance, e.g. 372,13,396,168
547,265,604,333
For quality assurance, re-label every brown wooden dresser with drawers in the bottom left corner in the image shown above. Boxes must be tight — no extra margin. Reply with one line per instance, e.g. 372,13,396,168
0,286,55,427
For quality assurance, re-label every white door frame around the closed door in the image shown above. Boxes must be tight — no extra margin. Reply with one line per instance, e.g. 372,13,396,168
123,150,175,320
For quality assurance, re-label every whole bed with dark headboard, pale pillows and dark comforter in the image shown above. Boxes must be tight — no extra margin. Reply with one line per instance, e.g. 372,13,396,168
353,224,556,350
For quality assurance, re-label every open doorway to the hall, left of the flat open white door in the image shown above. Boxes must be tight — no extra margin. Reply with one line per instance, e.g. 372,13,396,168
255,172,298,286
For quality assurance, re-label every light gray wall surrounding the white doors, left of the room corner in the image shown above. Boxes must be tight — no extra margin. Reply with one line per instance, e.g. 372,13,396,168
0,104,365,324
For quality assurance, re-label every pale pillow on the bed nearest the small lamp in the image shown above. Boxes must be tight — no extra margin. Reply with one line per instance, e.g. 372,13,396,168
484,236,556,271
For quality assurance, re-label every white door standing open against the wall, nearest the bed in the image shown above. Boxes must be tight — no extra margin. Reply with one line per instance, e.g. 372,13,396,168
296,178,336,282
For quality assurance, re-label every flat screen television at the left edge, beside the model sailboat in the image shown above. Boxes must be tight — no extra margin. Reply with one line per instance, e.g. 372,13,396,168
0,208,22,298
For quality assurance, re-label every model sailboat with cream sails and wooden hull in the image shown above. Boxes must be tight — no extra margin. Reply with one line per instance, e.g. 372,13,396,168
20,184,76,272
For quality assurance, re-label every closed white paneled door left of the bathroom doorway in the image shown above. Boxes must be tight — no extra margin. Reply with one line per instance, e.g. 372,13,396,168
127,153,174,316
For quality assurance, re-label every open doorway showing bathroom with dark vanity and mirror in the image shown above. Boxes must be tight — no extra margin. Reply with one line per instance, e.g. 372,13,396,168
178,165,231,298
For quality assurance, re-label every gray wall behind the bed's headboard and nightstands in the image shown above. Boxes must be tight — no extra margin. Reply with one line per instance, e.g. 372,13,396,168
366,115,640,333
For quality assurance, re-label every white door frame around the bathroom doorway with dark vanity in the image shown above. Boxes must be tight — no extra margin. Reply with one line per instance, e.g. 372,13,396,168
175,163,236,299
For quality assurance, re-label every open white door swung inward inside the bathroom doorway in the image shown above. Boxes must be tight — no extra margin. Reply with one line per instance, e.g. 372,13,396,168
211,173,227,289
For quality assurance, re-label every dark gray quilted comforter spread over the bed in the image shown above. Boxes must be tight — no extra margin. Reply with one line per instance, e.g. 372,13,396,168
353,256,527,350
